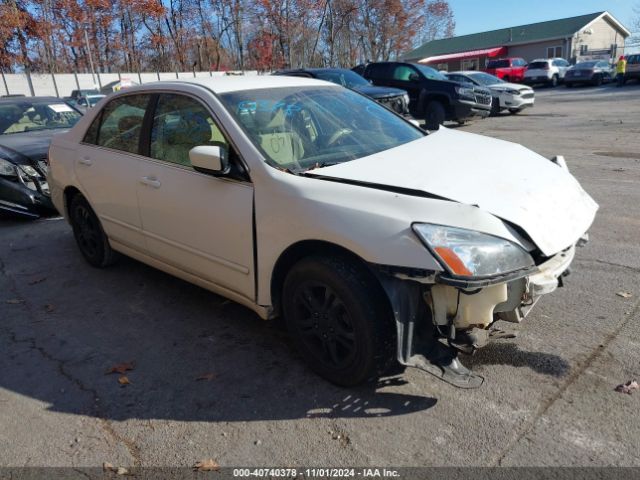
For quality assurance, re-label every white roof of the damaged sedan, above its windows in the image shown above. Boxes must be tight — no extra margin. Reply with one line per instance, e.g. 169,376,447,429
121,75,339,93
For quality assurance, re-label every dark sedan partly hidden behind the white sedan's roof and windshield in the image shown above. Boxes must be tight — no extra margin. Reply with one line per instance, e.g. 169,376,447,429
274,68,409,115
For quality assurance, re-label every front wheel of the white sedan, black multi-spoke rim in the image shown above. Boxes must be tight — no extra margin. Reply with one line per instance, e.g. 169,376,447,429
282,256,395,386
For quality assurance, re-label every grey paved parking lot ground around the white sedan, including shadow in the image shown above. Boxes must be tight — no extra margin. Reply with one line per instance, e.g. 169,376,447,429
0,84,640,467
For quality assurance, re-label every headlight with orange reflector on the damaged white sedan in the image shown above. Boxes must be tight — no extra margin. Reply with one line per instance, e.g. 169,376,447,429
413,223,535,277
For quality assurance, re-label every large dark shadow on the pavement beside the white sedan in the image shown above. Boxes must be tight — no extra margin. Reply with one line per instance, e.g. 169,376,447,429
0,221,436,422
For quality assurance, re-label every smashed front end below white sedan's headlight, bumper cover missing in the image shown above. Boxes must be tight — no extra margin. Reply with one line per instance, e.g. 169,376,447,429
381,240,587,388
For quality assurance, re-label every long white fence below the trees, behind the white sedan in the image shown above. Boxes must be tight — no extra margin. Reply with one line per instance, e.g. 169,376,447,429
0,71,258,97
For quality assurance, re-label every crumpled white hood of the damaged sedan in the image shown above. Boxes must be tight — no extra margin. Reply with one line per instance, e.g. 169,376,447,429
308,127,598,256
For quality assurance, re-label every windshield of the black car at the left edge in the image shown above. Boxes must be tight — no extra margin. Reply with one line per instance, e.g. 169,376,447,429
0,98,82,135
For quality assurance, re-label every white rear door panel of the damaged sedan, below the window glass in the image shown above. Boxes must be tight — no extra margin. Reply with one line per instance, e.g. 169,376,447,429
75,144,144,249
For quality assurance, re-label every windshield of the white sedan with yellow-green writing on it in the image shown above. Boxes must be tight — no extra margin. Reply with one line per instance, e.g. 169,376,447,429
220,87,425,173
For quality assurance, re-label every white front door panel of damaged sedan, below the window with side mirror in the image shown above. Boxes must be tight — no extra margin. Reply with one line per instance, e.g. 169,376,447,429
137,160,255,299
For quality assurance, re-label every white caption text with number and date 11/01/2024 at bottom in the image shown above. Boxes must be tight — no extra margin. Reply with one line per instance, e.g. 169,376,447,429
233,468,400,478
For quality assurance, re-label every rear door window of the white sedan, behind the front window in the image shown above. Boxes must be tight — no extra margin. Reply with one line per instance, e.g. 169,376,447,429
96,95,151,153
